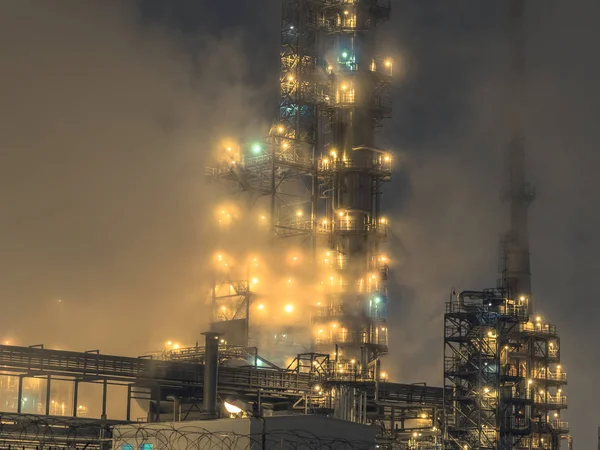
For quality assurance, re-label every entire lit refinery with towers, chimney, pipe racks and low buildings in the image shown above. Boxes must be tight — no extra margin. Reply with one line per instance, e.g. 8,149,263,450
0,0,572,450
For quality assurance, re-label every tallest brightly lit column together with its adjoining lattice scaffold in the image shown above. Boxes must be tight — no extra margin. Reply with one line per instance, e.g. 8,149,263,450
209,0,393,376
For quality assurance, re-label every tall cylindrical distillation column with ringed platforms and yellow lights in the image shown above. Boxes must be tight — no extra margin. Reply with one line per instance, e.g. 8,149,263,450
316,0,392,373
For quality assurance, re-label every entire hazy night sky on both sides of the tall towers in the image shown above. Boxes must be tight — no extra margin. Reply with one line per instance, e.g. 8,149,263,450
0,0,600,449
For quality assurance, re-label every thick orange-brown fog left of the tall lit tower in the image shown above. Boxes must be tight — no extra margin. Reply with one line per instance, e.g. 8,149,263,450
0,1,258,355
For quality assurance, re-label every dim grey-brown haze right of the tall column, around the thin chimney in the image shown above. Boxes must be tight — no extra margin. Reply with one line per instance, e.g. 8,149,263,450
385,0,600,448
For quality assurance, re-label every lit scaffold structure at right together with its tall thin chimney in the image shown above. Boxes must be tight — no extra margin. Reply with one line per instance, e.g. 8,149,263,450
444,0,570,450
